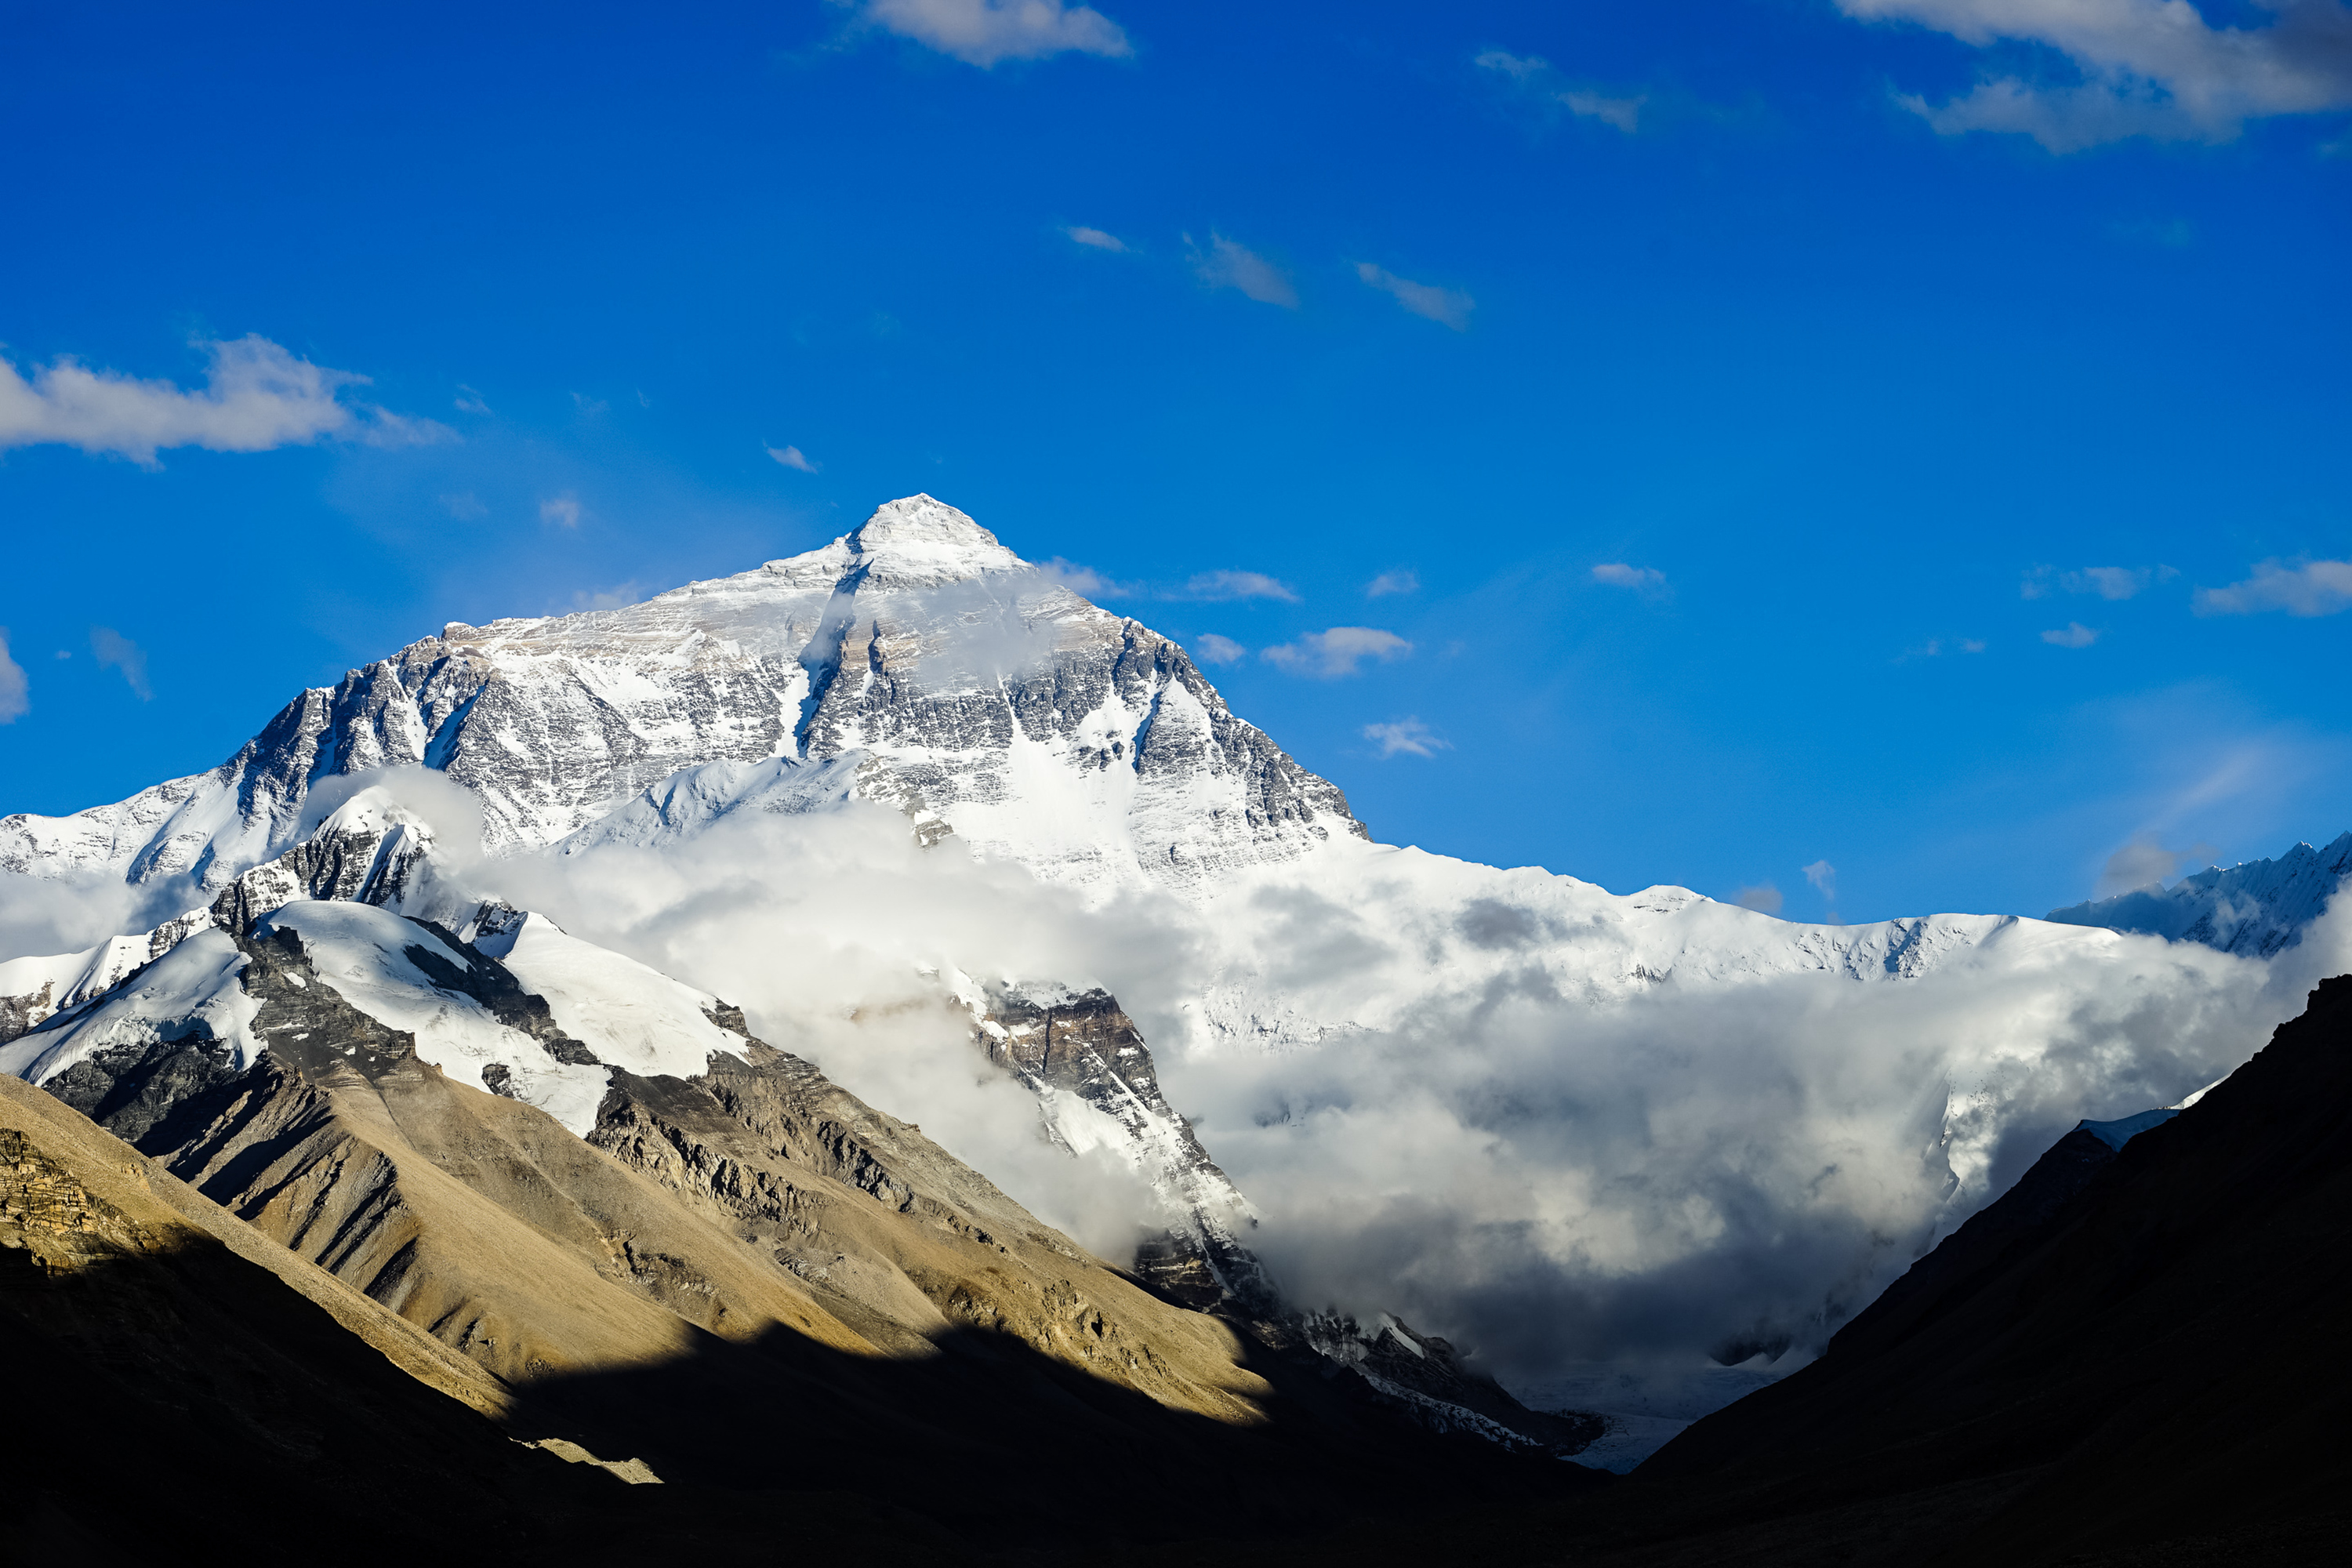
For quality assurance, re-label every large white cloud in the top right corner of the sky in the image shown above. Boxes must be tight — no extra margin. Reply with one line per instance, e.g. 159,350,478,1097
1837,0,2352,153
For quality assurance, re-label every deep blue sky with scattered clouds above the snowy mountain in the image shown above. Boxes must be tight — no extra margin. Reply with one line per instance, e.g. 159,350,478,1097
0,0,2352,919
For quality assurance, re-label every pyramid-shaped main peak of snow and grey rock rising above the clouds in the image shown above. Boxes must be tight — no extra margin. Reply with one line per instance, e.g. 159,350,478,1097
0,496,1362,895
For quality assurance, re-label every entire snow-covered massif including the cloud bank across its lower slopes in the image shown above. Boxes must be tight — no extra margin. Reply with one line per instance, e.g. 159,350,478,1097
0,496,2314,1429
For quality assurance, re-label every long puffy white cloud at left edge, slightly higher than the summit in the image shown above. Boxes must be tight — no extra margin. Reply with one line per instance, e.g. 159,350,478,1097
0,336,456,466
